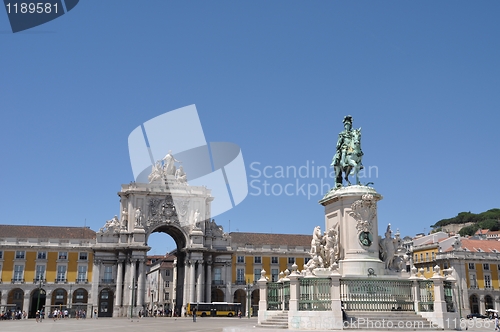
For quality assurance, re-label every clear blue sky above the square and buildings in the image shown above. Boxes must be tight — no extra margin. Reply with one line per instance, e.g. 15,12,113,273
0,0,500,254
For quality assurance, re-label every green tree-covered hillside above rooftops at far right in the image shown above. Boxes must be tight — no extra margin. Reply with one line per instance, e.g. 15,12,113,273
431,209,500,236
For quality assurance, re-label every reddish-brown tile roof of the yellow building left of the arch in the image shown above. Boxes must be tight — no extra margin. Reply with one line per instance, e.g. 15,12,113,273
0,225,95,239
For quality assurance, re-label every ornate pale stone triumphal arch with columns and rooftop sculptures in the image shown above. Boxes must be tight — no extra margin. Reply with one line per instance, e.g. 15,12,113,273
91,163,231,317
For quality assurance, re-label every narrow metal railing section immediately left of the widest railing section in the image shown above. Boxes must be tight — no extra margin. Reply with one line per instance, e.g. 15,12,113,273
299,278,332,311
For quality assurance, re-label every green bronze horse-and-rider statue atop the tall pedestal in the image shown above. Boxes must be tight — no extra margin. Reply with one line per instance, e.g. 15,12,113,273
331,115,363,188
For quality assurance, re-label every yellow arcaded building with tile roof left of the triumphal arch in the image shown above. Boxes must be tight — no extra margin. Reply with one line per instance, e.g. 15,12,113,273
0,225,96,317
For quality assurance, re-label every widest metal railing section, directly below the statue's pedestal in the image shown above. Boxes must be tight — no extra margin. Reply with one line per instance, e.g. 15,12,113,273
340,279,415,311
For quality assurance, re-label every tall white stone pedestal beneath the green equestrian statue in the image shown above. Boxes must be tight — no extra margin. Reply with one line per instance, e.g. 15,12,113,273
319,186,384,276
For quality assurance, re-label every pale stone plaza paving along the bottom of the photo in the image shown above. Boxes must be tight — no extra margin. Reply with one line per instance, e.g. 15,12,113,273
0,317,494,332
